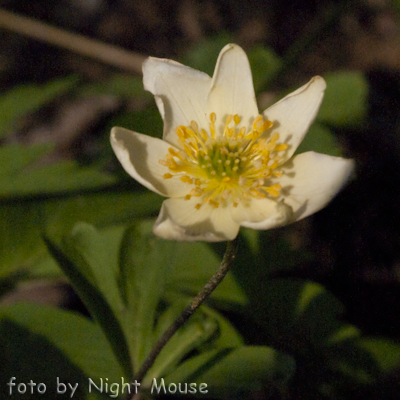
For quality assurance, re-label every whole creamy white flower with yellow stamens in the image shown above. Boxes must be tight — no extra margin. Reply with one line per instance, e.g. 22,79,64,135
111,44,353,241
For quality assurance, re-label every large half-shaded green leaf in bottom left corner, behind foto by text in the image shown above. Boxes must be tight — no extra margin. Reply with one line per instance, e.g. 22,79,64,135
0,303,124,399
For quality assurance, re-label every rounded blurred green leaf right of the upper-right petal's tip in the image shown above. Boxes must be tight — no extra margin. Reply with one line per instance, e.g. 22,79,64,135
317,72,368,126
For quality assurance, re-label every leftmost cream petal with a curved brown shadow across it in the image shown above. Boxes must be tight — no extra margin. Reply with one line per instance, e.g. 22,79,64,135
111,127,190,197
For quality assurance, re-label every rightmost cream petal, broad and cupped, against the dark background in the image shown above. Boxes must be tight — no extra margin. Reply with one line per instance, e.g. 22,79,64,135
279,151,354,221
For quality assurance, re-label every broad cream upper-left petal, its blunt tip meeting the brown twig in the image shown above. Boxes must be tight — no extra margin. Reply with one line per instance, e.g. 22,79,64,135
143,57,211,147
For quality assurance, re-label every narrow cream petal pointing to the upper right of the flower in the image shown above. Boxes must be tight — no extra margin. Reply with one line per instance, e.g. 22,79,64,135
263,76,326,164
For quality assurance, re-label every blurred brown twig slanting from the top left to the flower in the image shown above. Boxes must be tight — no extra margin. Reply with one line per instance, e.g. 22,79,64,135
0,8,146,74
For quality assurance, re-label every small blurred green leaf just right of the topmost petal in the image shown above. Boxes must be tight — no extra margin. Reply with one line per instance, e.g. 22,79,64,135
247,46,282,94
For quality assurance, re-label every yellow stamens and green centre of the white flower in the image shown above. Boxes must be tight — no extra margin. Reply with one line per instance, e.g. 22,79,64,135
159,113,287,209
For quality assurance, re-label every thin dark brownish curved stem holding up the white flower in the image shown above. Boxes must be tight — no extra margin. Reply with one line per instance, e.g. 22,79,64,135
127,238,238,400
